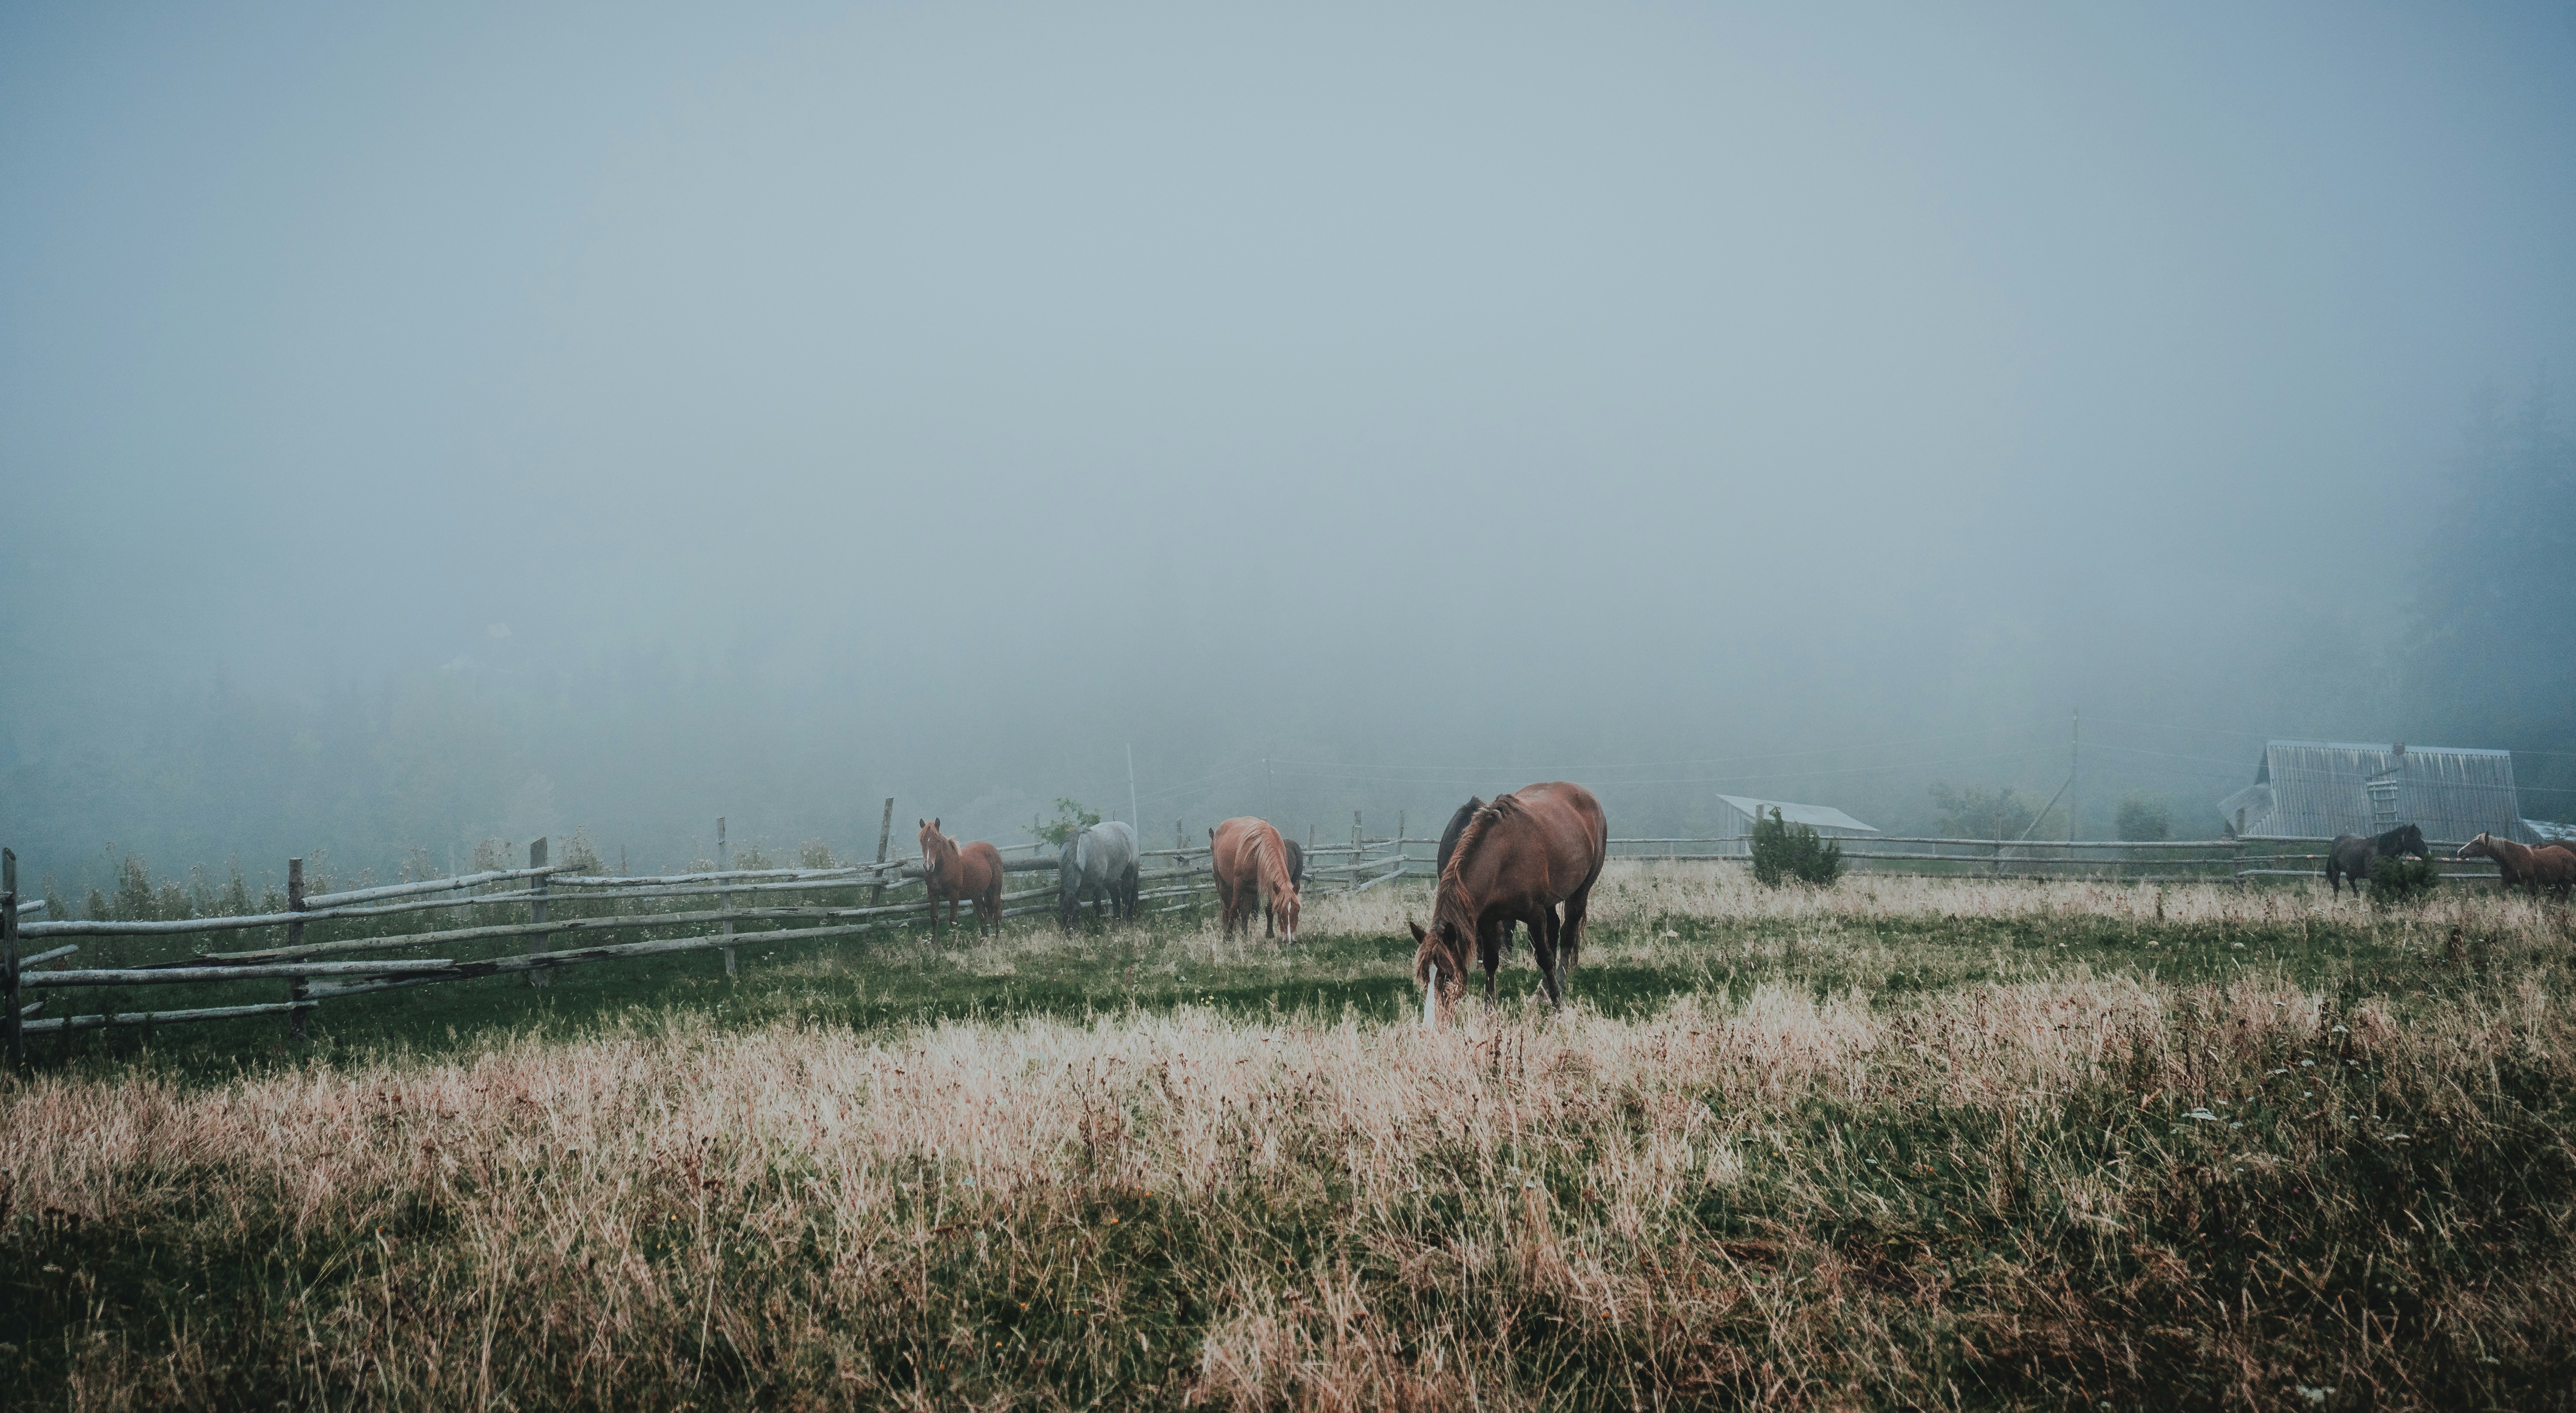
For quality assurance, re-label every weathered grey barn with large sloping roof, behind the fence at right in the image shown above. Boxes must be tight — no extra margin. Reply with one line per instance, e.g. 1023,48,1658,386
2218,740,2537,843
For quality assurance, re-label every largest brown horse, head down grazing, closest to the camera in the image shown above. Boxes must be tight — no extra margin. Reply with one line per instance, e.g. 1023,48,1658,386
1412,781,1610,1021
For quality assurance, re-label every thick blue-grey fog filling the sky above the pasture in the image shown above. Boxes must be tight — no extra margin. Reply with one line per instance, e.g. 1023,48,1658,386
0,3,2576,890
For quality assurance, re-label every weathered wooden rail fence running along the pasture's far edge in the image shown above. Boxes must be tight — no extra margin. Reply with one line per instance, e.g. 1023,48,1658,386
0,799,2496,1067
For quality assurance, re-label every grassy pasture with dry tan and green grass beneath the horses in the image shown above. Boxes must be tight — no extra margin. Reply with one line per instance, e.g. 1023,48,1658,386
0,864,2576,1408
